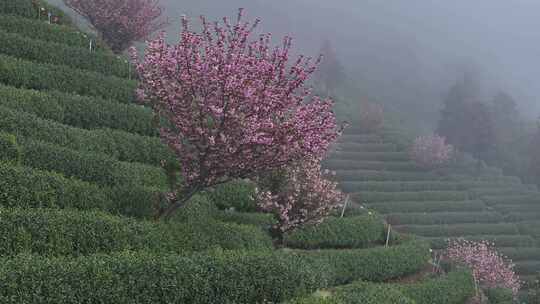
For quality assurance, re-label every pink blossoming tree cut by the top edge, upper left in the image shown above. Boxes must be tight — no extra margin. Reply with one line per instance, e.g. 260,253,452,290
64,0,167,53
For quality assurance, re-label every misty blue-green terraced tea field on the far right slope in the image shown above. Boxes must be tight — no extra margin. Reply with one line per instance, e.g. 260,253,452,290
326,129,540,290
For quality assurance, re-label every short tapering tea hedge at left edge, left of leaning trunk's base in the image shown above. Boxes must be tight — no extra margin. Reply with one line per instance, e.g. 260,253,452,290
0,163,112,210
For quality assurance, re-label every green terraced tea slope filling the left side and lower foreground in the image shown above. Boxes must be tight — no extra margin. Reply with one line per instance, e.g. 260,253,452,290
0,0,474,304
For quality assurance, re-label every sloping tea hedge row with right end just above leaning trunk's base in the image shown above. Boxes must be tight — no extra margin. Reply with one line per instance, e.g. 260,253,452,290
21,140,168,189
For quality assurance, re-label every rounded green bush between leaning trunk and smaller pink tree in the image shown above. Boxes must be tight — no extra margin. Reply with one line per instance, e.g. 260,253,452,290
205,180,257,212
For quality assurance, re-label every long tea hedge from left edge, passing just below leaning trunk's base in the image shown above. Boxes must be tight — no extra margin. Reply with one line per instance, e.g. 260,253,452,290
0,208,272,256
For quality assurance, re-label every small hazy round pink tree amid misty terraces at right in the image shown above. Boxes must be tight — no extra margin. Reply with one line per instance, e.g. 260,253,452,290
411,135,454,169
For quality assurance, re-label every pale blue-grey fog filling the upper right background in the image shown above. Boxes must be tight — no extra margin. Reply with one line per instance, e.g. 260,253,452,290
153,0,540,129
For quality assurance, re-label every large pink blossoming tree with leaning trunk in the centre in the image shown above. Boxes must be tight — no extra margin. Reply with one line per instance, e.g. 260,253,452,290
132,10,341,217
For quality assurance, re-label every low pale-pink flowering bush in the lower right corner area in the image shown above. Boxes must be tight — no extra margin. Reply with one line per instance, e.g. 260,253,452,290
447,240,521,295
